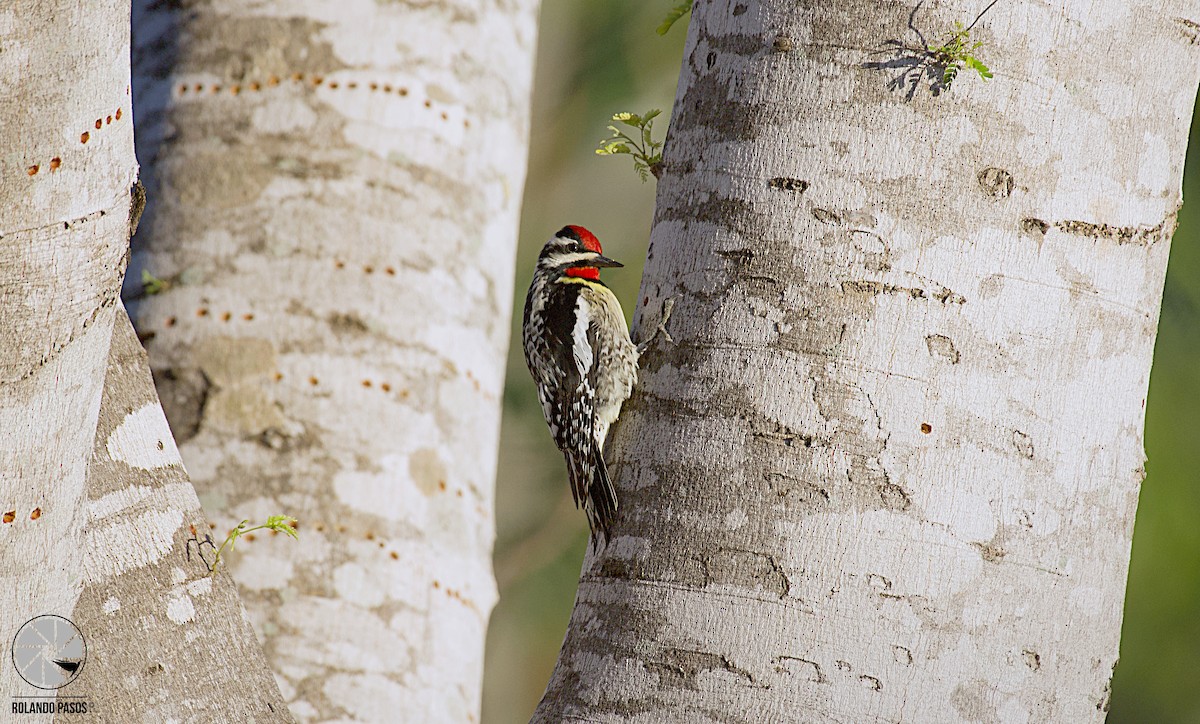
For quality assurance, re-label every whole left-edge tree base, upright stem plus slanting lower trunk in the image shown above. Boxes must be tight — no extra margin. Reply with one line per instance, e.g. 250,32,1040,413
0,0,289,722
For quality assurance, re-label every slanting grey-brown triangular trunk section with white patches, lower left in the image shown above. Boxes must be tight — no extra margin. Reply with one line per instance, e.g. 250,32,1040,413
66,309,292,722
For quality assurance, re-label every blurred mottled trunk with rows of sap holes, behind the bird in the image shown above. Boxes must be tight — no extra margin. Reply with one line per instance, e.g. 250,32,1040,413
131,0,536,722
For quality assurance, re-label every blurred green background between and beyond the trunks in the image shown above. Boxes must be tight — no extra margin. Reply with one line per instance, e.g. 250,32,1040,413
484,0,1200,724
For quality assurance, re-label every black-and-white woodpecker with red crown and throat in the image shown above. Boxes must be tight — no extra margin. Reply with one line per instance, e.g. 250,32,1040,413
522,226,637,541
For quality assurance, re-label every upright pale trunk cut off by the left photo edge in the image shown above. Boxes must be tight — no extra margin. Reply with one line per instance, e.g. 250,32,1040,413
0,0,137,691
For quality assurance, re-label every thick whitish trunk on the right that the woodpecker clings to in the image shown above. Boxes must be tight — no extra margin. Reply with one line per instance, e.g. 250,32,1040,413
534,0,1200,723
